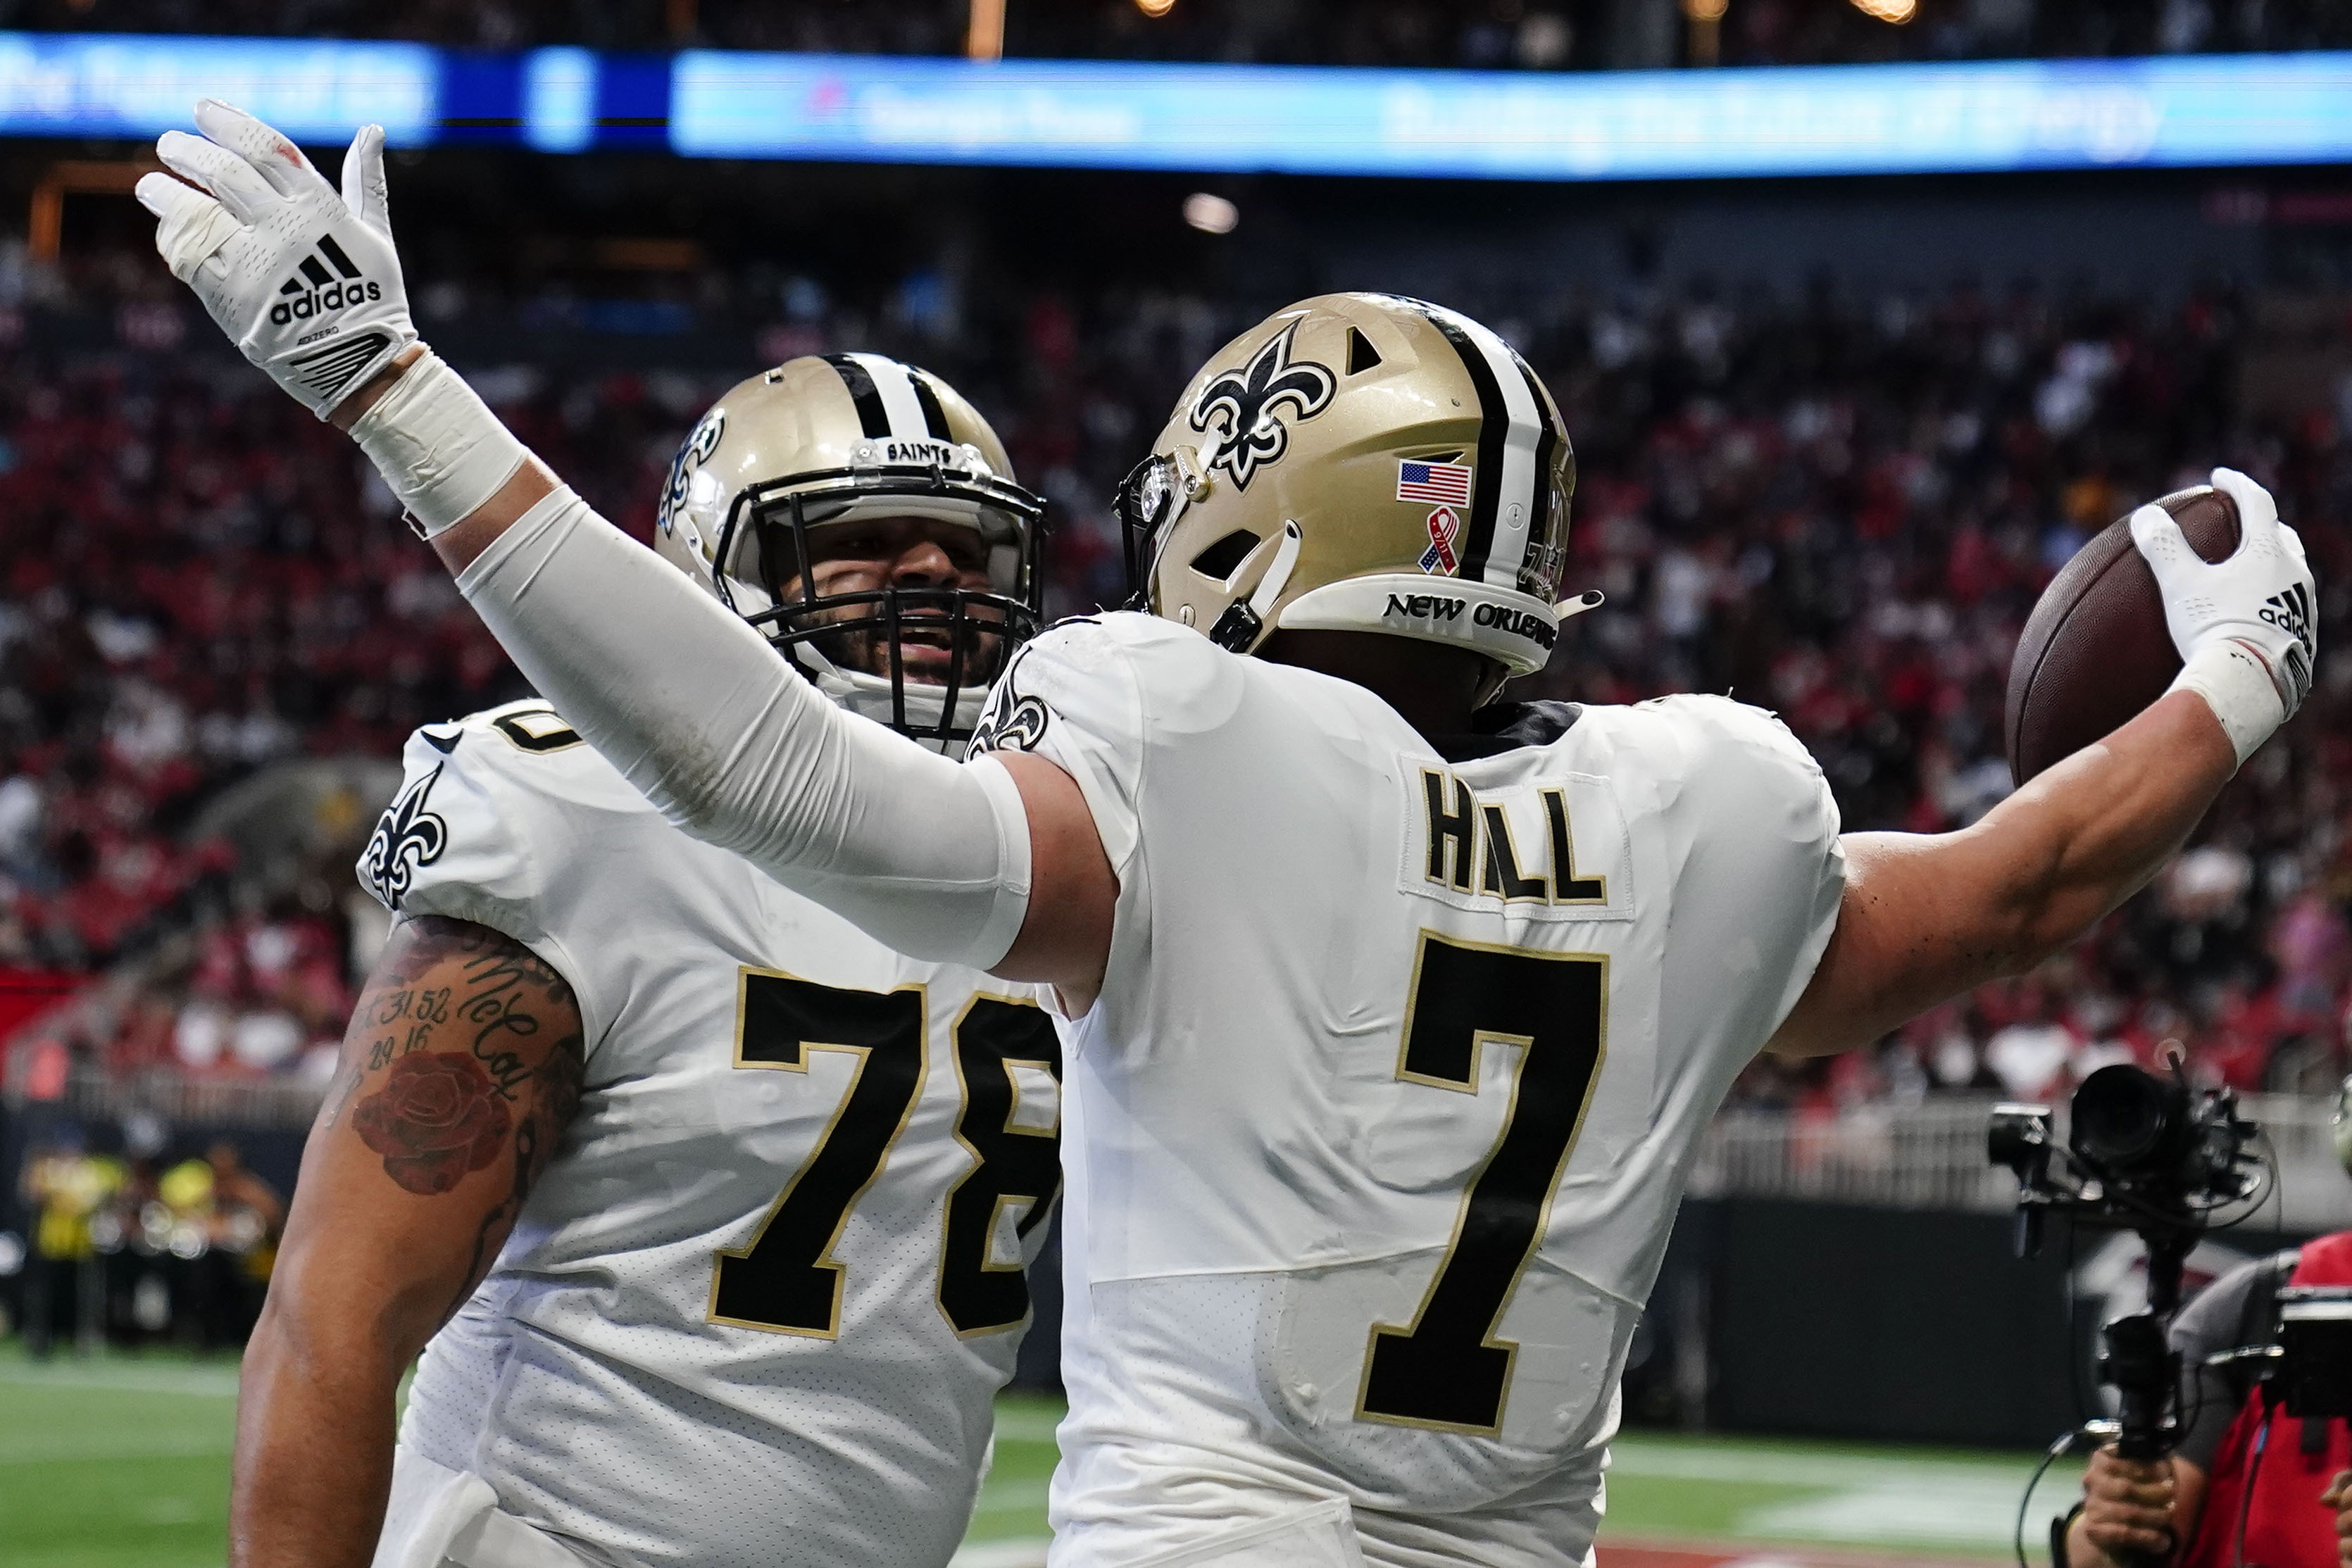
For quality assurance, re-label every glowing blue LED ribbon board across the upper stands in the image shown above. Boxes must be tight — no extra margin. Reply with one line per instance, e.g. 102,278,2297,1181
0,33,2352,181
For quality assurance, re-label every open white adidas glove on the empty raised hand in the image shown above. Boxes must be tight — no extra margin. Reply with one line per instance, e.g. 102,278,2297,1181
139,99,416,418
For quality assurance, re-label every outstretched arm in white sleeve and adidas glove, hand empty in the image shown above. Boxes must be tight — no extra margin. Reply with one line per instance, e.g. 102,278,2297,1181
139,101,1115,999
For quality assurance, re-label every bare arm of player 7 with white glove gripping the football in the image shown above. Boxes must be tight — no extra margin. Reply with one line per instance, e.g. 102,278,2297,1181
1766,468,2317,1055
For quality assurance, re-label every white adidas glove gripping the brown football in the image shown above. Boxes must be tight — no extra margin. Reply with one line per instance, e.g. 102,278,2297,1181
2131,468,2319,762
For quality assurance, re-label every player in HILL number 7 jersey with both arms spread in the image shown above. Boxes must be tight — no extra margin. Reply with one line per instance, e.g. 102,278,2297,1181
156,120,2315,1568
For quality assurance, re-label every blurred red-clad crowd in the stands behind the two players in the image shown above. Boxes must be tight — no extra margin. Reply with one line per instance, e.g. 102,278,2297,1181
0,227,2352,1128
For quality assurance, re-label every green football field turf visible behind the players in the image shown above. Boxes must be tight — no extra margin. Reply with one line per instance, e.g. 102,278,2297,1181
0,1345,2075,1568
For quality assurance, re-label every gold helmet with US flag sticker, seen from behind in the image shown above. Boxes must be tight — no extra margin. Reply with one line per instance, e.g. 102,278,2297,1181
1118,294,1599,700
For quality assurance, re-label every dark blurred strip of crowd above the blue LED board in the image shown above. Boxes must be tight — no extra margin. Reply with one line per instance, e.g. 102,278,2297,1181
0,0,2352,70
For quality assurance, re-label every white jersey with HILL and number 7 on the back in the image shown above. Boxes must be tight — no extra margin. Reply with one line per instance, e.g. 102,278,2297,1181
978,613,1844,1568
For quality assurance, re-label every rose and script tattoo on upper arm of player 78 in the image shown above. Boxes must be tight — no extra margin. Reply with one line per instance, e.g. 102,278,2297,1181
327,915,586,1312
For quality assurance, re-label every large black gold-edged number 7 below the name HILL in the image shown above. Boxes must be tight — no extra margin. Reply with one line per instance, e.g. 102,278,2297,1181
1357,931,1609,1434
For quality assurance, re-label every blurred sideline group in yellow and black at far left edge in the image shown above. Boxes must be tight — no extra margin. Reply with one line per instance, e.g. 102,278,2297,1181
0,1117,284,1357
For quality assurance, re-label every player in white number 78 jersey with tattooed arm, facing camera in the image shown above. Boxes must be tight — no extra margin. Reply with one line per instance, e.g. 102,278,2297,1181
220,355,1058,1568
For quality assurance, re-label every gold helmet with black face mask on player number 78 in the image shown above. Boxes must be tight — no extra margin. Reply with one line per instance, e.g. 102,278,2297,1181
654,355,1044,750
